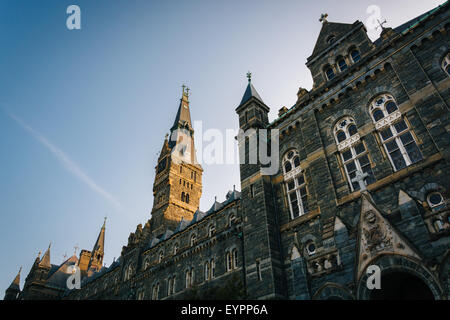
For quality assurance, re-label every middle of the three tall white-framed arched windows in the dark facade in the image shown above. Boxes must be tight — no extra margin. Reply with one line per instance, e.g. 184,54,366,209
334,117,375,191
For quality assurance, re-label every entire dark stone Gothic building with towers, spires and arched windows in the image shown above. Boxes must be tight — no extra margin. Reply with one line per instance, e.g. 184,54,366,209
5,2,450,299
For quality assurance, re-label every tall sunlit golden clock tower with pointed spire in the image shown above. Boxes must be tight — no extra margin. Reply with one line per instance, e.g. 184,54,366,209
150,86,203,237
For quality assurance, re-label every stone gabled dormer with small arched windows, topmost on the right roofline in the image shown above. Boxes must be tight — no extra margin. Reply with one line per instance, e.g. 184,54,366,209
306,15,372,88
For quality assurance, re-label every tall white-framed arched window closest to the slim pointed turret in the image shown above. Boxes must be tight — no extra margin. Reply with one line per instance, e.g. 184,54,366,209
283,150,308,219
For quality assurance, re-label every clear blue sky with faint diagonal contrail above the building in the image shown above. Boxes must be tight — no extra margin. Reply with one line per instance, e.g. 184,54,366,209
0,0,444,296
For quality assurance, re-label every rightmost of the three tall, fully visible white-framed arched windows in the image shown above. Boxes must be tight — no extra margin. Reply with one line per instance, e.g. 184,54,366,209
369,94,422,171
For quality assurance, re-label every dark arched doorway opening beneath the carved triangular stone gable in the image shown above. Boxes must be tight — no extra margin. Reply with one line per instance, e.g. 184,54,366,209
369,271,434,300
